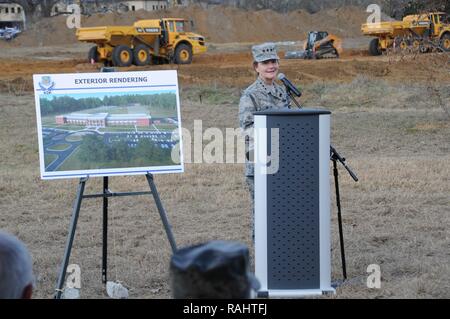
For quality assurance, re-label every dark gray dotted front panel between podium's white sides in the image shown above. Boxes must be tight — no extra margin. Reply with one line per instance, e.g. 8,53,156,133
267,115,320,289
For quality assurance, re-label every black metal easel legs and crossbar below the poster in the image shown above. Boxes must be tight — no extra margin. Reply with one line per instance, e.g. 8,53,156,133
55,173,177,299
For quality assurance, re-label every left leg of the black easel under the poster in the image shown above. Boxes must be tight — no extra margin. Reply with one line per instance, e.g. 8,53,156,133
55,178,87,299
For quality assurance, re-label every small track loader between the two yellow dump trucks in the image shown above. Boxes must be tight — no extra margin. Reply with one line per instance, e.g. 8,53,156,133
285,31,342,59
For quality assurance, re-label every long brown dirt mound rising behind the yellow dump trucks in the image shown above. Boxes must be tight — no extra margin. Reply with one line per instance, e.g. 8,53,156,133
0,5,367,47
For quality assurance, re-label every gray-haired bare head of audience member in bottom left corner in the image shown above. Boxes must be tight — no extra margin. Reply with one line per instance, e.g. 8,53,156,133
0,231,34,299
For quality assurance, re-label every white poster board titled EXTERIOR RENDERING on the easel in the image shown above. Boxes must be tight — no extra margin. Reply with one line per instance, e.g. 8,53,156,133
33,70,184,179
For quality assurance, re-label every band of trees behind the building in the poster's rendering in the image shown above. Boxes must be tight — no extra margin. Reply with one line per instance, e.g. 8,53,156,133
40,93,177,116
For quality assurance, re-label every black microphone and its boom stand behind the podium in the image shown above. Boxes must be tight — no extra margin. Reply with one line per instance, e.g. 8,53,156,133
286,86,358,280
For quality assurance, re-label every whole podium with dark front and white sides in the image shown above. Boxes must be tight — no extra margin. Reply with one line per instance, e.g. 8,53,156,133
255,111,331,296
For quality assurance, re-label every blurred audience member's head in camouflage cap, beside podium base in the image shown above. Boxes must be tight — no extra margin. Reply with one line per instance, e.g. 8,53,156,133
170,241,260,299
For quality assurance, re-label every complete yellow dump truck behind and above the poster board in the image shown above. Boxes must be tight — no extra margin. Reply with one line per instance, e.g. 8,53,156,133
76,18,207,66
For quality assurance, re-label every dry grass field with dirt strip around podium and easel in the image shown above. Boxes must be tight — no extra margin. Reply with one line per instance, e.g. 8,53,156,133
0,42,450,298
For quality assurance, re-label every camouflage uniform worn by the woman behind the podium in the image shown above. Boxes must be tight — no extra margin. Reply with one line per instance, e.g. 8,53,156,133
239,77,290,203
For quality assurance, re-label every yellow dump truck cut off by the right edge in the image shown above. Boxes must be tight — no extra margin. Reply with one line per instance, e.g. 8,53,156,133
361,12,450,55
